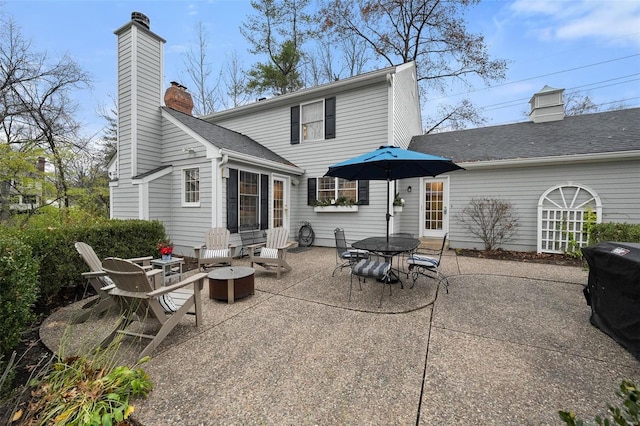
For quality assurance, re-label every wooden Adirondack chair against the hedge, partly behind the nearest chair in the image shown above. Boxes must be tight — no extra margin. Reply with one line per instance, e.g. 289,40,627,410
73,241,153,324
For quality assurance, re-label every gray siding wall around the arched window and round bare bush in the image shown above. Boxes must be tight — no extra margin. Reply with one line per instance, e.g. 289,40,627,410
449,161,640,251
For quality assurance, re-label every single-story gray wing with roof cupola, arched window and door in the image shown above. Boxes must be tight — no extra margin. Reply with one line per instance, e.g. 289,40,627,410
408,86,640,253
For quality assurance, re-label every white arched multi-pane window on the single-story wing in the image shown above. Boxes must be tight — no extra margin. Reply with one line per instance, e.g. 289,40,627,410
538,183,602,253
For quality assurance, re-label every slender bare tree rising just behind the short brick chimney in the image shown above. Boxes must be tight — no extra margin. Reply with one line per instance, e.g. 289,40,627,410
184,21,222,115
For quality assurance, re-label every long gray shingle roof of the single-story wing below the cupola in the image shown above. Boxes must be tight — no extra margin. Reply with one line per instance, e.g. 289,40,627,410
409,108,640,162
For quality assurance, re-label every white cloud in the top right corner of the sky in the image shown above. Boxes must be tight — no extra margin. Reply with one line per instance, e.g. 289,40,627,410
510,0,640,45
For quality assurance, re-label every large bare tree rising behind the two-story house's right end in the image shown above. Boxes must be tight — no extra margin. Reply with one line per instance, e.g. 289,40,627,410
319,0,507,129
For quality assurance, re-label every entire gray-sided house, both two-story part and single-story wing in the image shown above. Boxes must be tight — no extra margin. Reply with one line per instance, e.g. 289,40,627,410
110,14,640,256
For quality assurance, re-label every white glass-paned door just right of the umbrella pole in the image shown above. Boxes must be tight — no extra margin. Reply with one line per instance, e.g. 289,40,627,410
420,176,449,238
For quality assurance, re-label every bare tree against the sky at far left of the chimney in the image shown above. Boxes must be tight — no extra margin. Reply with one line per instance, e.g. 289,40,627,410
0,14,90,215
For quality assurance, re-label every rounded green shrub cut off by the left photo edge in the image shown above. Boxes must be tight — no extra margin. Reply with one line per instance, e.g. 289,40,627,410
0,235,39,380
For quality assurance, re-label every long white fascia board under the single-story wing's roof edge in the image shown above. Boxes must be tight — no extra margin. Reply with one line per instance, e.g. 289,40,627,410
456,150,640,170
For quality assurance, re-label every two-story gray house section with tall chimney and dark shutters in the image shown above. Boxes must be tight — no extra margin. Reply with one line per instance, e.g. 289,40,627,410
109,13,421,256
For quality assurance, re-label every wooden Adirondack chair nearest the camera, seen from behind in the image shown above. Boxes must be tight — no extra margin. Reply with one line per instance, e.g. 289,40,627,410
102,257,207,358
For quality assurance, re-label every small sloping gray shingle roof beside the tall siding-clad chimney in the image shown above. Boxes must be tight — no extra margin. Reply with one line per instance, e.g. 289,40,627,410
162,107,295,166
